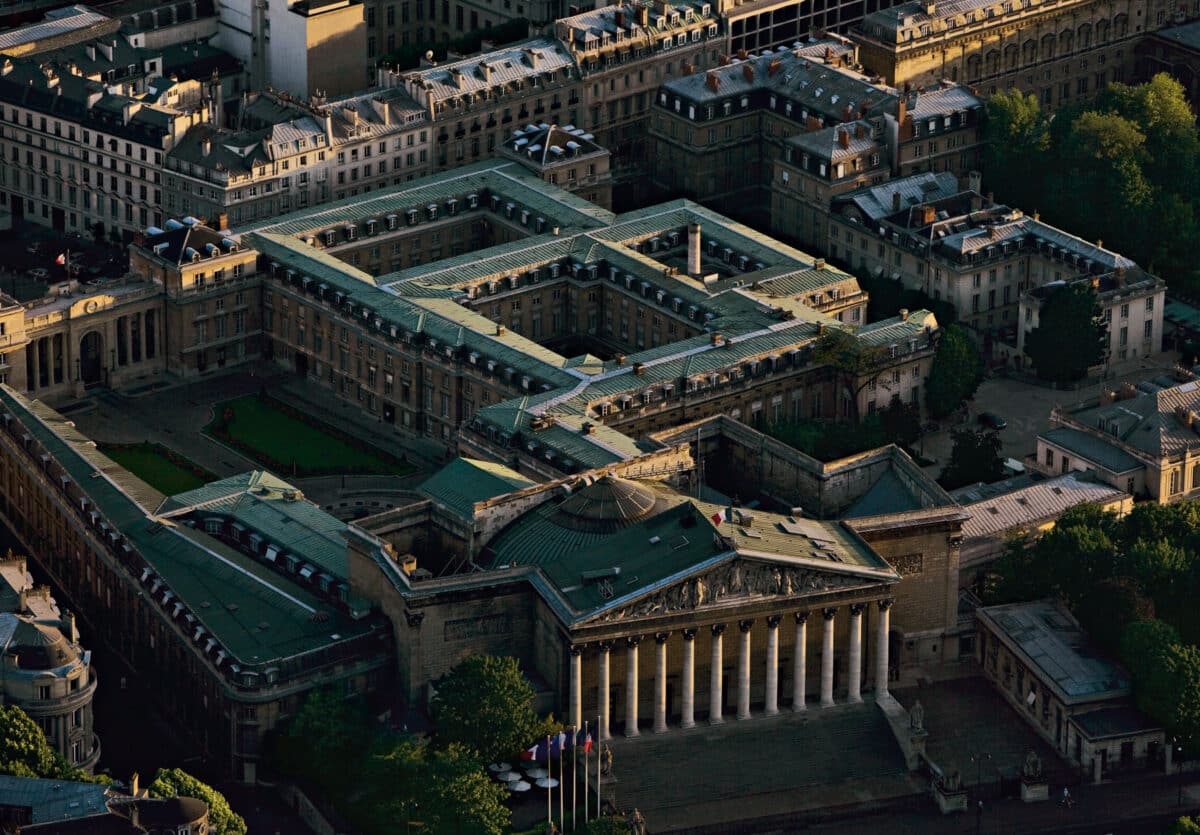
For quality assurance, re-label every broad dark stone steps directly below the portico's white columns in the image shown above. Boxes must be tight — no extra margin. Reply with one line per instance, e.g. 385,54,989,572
604,699,912,833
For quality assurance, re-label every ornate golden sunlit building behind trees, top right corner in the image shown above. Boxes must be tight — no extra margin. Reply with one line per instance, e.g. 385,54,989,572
850,0,1171,110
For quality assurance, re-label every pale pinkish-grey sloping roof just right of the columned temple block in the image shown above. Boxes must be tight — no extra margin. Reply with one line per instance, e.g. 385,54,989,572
962,474,1127,540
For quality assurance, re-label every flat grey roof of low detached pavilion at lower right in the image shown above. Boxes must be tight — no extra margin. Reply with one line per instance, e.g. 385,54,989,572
976,600,1132,704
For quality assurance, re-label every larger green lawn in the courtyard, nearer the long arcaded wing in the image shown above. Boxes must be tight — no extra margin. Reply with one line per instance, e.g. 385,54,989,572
205,395,412,477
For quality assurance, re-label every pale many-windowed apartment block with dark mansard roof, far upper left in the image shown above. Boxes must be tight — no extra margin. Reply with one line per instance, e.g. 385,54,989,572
0,52,210,241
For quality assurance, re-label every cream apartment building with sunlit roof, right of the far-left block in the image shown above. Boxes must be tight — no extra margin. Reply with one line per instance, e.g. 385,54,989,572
164,88,432,228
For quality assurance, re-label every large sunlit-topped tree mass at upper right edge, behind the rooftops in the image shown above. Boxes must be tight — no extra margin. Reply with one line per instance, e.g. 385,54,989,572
983,73,1200,290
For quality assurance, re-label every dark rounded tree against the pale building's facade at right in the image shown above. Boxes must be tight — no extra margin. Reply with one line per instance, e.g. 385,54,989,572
1025,282,1104,383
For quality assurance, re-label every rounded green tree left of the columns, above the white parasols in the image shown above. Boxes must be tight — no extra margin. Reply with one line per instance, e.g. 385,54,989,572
431,655,538,762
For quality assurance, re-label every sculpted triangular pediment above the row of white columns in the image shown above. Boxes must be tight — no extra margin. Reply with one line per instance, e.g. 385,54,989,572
582,558,892,624
